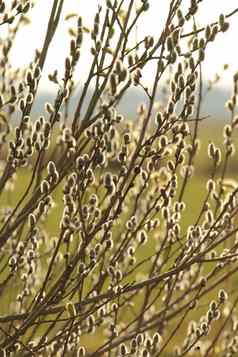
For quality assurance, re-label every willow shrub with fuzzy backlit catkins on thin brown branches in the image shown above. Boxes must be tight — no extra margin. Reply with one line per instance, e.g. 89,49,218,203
0,0,238,357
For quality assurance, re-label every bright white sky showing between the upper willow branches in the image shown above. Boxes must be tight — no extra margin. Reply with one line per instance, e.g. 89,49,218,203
8,0,238,90
